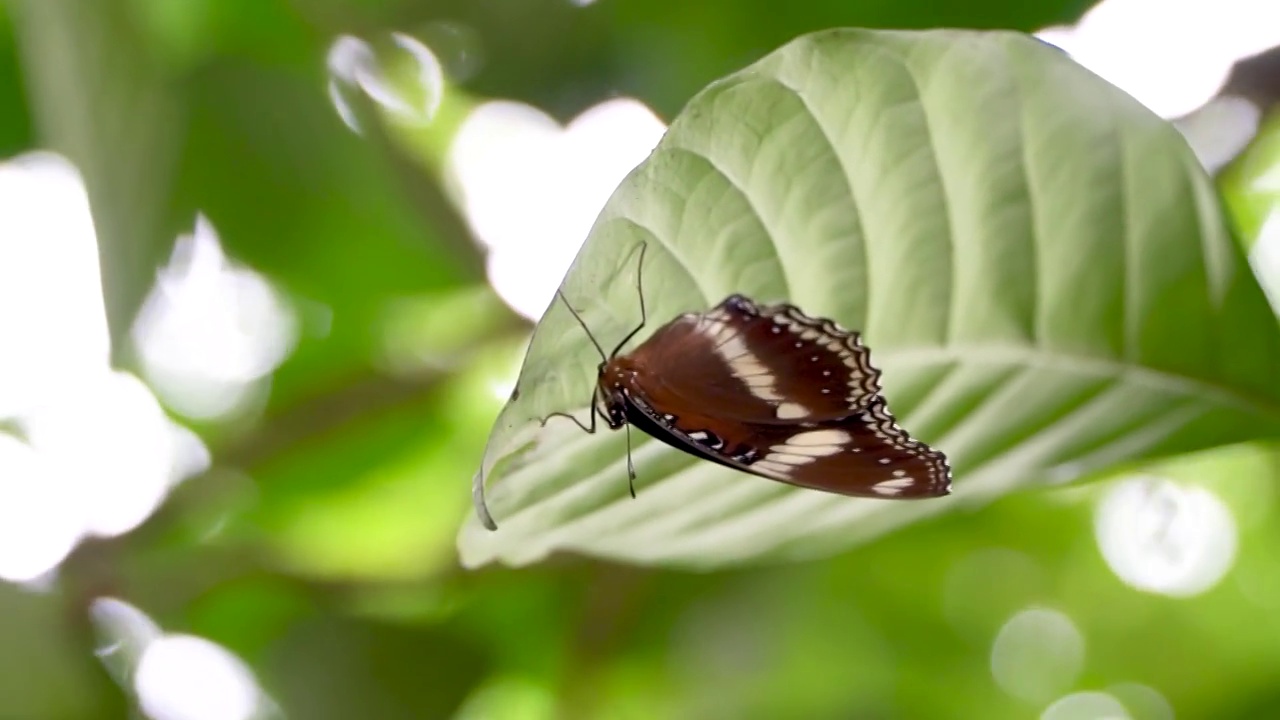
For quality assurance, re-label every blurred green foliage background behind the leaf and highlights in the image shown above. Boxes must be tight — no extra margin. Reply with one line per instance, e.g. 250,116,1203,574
0,0,1280,720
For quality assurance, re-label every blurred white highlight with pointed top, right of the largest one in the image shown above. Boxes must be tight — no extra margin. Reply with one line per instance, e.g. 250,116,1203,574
133,217,298,419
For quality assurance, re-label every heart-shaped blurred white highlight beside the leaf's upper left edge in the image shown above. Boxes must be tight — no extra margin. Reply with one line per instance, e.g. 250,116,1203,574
448,97,667,318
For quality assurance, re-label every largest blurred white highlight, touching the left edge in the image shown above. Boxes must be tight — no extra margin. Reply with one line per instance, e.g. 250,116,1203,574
0,152,209,584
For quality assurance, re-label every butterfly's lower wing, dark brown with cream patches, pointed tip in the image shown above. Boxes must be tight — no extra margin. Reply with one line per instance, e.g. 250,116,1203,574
627,395,951,500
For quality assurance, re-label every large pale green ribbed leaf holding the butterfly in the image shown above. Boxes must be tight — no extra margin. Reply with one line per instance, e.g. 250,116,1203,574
460,29,1280,566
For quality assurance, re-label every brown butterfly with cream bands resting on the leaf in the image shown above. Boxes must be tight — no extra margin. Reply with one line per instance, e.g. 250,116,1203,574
541,245,951,500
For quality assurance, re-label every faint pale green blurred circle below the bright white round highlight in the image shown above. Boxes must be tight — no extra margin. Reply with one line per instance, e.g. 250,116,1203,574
991,607,1084,702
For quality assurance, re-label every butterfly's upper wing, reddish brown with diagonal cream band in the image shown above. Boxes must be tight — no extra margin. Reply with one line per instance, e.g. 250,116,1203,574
628,295,881,425
